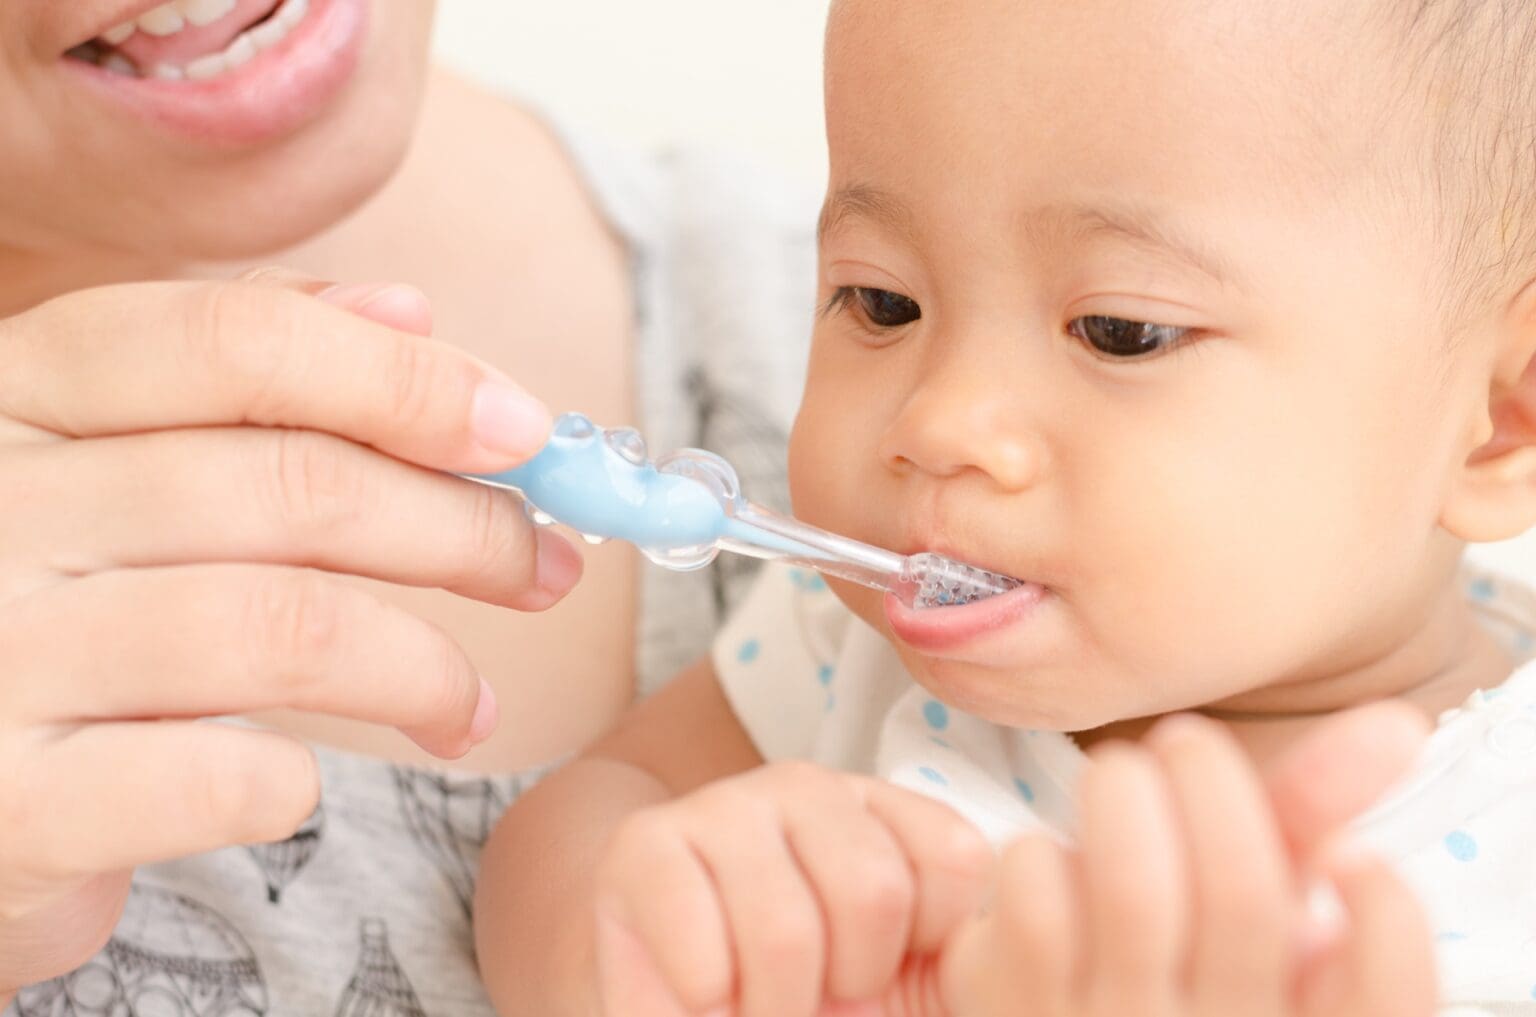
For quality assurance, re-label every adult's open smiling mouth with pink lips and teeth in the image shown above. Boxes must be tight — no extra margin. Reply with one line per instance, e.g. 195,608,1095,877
65,0,369,144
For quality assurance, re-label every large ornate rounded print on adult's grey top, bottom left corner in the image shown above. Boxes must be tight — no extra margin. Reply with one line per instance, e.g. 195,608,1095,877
15,885,267,1017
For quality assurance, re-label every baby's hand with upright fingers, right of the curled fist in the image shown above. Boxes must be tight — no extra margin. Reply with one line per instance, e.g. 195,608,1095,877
942,717,1435,1017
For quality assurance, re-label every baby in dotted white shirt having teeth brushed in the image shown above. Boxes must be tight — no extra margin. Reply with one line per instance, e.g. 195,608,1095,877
478,0,1536,1017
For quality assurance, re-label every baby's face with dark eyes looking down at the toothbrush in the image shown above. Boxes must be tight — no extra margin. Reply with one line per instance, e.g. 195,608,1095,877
791,0,1487,730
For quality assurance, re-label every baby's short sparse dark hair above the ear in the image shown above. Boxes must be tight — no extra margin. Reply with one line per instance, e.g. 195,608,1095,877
1378,0,1536,332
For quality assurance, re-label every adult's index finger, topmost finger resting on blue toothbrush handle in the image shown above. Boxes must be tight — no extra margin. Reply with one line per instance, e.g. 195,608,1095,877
0,280,550,473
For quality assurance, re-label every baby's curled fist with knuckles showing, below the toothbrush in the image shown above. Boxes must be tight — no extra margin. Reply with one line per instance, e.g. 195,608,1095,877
596,764,994,1017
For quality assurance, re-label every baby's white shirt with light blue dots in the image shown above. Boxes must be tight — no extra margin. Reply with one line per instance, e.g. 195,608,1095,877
713,567,1536,1017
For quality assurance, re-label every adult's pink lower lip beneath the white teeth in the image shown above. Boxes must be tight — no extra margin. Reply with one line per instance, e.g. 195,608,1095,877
63,0,369,144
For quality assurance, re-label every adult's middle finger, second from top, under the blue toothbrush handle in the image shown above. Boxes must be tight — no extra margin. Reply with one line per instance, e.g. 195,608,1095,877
0,427,581,610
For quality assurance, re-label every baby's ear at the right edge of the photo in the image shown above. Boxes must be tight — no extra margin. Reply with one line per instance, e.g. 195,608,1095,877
1441,281,1536,542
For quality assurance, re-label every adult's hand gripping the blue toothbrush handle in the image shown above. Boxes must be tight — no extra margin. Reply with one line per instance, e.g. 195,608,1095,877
0,270,581,1006
